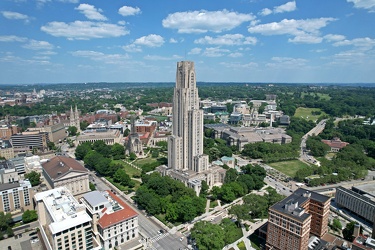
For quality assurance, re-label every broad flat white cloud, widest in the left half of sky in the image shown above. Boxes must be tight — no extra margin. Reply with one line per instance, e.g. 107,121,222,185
41,21,129,40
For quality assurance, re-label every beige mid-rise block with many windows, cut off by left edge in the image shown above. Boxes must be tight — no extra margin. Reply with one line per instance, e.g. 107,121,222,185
0,179,33,213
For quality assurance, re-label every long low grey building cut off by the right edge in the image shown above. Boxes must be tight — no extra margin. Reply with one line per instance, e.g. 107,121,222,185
335,184,375,223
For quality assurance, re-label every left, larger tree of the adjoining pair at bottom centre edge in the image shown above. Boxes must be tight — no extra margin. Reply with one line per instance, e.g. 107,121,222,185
191,221,225,250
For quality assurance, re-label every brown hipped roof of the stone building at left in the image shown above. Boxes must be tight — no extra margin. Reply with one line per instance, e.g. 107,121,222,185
42,155,88,180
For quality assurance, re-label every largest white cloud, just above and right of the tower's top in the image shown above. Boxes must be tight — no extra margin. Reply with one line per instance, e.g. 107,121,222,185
162,9,255,33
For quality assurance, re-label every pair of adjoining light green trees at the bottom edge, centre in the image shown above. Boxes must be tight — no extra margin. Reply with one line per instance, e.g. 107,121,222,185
190,218,242,250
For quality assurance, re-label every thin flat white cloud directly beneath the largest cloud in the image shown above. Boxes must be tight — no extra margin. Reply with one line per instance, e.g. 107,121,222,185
194,34,257,45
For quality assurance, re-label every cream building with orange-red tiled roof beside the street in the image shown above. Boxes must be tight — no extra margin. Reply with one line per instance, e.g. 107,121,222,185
81,190,139,249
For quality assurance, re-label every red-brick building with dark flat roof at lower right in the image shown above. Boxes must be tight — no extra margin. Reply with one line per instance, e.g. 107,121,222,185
266,188,330,250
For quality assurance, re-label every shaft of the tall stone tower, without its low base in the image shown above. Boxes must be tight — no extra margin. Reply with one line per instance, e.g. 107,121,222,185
168,61,208,173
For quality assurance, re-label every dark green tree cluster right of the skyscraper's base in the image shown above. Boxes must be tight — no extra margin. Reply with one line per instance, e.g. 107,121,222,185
211,164,266,202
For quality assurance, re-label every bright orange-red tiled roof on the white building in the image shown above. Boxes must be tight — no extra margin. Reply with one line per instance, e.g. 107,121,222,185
98,190,138,228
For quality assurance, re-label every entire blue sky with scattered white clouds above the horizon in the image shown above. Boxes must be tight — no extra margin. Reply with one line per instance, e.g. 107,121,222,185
0,0,375,84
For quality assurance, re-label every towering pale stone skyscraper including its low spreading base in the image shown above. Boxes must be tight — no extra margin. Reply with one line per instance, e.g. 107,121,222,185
157,61,226,195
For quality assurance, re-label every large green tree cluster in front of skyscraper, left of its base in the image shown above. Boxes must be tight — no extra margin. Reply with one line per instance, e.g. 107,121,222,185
134,173,206,222
